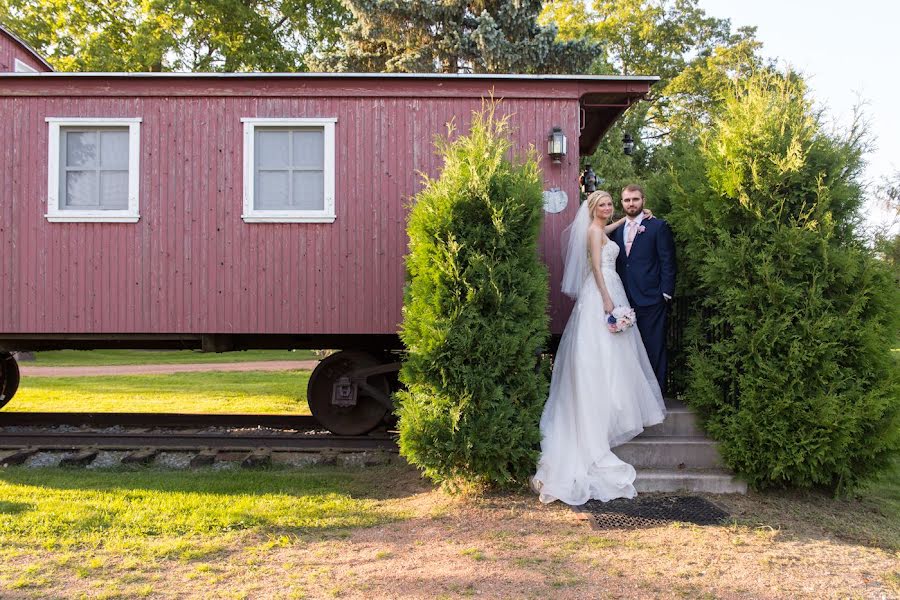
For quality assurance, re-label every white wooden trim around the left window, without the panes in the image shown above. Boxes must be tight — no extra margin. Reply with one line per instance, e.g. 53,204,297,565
44,117,141,223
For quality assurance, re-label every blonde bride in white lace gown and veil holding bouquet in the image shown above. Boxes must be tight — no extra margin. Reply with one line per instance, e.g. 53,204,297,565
532,191,665,506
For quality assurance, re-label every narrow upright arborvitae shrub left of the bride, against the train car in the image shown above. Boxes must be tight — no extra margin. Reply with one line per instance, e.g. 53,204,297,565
398,102,548,486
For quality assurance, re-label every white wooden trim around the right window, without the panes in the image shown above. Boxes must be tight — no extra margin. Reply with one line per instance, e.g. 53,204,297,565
241,117,337,223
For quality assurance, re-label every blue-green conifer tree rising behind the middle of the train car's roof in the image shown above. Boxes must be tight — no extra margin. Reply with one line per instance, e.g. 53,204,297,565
320,0,596,73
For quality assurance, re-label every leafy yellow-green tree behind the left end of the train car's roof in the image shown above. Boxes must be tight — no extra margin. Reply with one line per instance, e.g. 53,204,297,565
0,0,349,72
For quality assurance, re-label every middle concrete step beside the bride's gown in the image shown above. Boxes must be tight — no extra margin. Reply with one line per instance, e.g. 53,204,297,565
613,436,722,469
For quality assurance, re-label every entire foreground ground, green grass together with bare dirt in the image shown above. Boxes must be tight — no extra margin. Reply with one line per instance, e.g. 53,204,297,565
0,465,900,600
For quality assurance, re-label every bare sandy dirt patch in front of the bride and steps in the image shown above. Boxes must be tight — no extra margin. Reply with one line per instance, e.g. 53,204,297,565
234,495,900,599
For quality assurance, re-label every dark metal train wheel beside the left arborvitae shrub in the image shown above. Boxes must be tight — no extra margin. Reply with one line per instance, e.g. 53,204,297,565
306,350,390,435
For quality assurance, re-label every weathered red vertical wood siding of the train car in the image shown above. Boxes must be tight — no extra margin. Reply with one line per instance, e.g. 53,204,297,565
0,77,652,334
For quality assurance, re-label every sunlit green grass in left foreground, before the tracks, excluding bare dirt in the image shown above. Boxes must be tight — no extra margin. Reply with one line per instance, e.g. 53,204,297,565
0,467,428,598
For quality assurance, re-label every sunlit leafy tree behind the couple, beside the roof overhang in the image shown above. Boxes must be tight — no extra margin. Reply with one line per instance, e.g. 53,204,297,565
540,0,771,200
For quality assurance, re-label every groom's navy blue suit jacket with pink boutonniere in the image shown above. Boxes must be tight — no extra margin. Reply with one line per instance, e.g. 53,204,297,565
612,217,675,306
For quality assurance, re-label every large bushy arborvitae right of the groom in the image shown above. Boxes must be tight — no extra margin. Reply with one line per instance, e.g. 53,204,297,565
671,74,900,490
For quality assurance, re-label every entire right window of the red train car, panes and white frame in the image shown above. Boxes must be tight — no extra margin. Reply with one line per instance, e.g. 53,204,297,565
241,117,337,223
